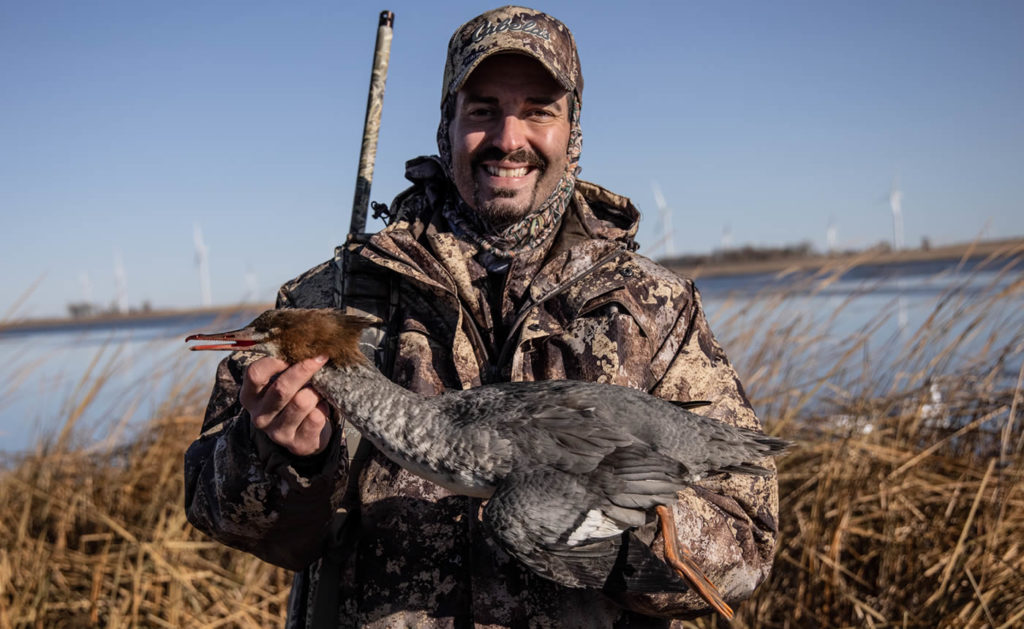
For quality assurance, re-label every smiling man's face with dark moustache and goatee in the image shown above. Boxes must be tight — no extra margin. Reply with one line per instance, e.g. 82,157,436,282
450,54,569,227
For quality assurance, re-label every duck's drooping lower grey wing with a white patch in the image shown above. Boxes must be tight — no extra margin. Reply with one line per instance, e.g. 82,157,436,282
483,460,688,592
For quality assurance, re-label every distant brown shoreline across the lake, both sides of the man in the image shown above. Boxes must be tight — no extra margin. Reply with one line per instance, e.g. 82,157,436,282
0,238,1024,335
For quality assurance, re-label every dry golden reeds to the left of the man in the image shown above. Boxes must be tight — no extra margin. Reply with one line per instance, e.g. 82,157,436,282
0,331,291,629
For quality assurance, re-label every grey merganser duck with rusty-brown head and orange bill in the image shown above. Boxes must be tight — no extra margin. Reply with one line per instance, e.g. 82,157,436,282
185,308,788,619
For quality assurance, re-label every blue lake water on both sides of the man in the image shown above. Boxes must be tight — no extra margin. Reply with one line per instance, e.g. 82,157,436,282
0,261,1024,452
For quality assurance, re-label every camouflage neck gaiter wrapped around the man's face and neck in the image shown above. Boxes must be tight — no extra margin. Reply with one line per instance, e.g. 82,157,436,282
437,91,583,261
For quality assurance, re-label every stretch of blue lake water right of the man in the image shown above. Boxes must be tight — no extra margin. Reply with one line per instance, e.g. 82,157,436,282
697,260,1024,420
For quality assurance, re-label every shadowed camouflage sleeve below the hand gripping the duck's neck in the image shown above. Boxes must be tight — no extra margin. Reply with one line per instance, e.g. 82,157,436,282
184,280,348,571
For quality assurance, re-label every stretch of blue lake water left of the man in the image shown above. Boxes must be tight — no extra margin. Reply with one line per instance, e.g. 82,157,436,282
0,312,260,452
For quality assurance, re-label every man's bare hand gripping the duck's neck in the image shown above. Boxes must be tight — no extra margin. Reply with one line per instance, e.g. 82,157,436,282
239,357,332,456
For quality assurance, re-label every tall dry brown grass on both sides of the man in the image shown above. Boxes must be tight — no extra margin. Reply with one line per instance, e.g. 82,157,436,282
0,252,1024,629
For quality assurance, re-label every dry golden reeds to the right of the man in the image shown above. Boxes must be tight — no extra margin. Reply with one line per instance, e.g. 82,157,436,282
697,251,1024,628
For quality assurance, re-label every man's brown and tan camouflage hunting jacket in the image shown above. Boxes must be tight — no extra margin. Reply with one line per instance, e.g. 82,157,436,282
185,160,778,628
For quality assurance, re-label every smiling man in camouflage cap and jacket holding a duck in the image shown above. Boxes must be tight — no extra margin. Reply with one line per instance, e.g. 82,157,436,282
185,7,777,627
